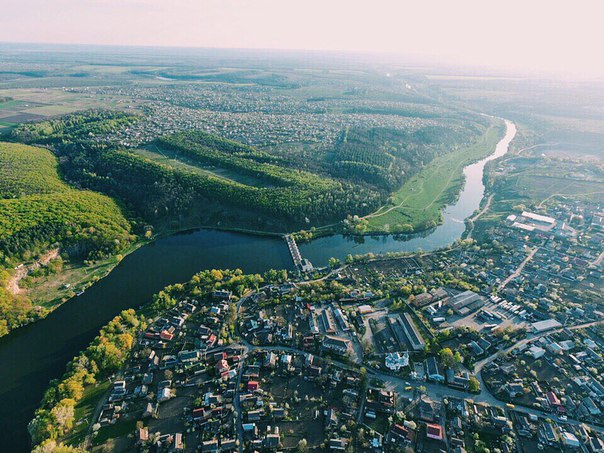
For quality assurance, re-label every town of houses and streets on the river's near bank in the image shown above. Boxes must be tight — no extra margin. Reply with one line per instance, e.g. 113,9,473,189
29,189,604,453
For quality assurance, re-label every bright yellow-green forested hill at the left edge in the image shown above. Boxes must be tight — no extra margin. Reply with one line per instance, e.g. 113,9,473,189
0,142,133,335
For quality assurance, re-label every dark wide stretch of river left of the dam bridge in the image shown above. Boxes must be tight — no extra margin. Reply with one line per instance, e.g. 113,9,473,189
0,230,292,451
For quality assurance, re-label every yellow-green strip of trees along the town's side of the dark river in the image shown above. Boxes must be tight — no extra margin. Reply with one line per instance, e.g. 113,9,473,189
29,269,278,452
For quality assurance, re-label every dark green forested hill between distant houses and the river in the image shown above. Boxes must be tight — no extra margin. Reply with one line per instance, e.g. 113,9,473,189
11,110,480,232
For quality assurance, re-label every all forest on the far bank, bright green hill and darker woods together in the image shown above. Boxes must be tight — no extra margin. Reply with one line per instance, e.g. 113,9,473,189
0,104,485,334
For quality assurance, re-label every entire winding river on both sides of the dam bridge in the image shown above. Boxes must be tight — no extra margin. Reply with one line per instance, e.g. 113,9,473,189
0,121,516,452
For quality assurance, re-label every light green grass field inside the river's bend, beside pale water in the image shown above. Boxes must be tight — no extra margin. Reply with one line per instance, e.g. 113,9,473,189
366,120,503,233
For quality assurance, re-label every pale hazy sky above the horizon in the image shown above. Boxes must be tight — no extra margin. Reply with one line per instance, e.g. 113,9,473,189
0,0,604,77
